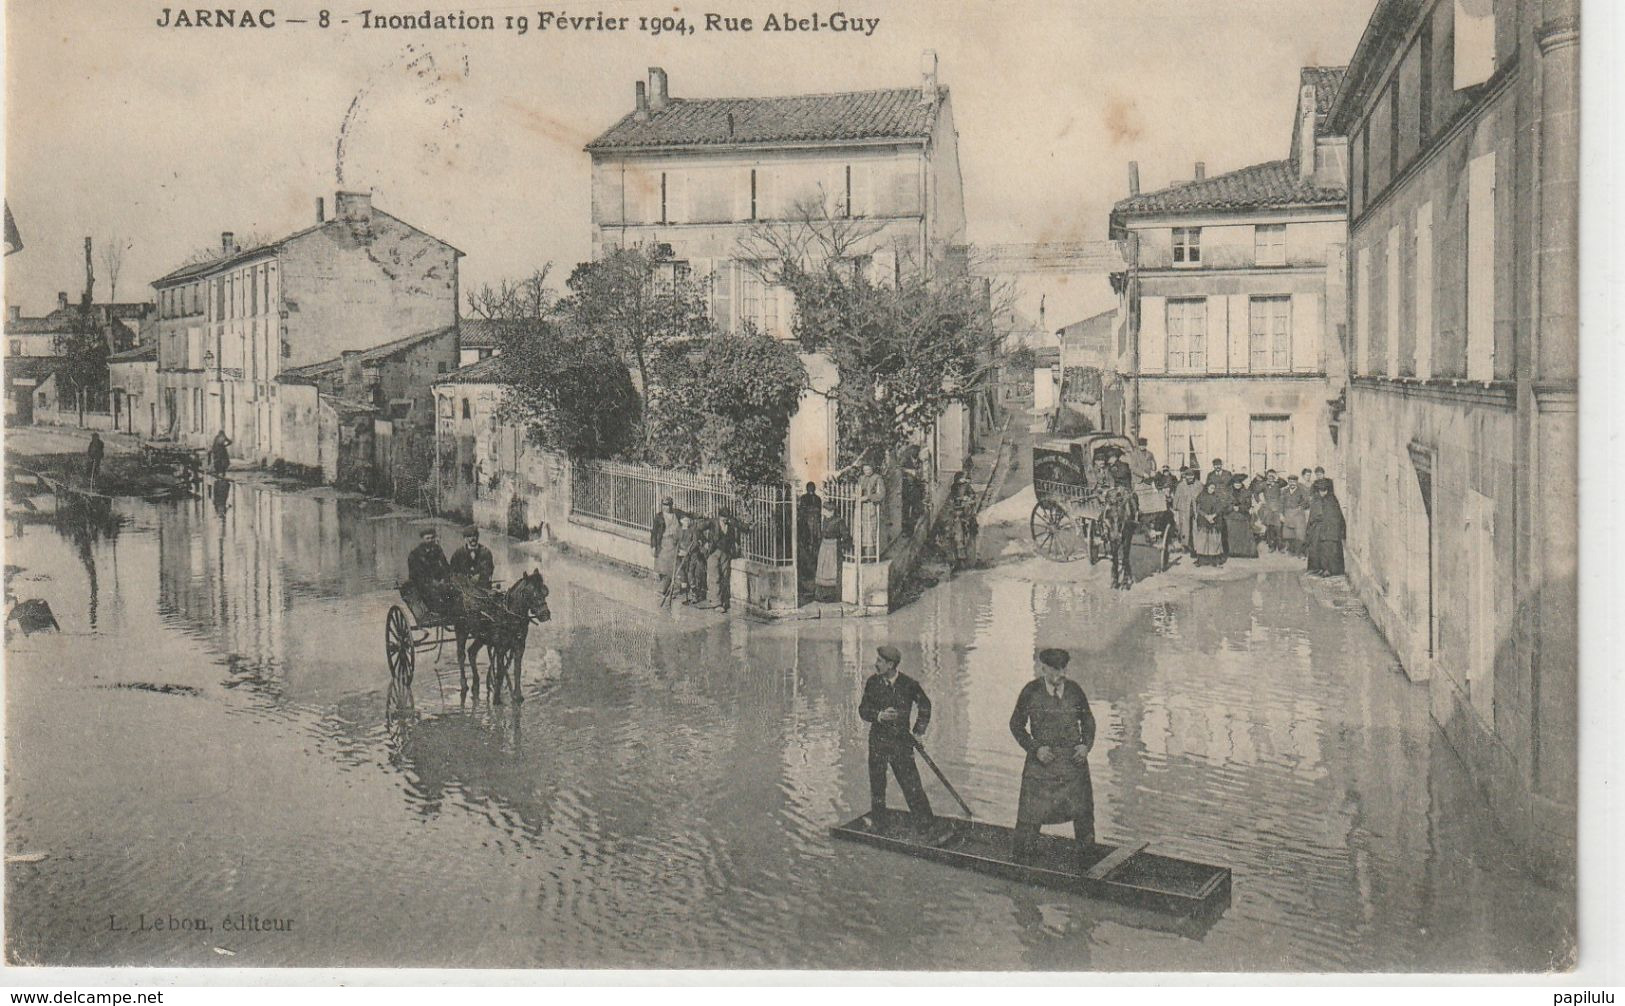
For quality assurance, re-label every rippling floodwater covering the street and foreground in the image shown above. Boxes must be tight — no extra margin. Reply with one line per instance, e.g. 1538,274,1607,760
5,484,1575,970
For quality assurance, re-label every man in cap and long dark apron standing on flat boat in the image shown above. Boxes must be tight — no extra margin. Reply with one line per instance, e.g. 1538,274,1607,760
1011,648,1095,869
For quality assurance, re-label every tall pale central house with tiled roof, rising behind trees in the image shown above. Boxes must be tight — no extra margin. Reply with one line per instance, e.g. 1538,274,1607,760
587,54,965,338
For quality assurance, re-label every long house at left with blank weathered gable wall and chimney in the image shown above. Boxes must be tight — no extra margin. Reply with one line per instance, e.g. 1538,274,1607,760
153,192,462,460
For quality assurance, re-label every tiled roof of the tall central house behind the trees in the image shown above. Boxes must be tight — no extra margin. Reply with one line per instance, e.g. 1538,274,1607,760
587,88,947,151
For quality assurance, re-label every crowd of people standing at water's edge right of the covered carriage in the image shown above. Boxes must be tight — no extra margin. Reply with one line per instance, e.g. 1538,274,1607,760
1157,458,1347,577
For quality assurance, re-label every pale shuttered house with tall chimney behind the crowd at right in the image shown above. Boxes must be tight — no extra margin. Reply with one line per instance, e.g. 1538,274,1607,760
1112,67,1347,473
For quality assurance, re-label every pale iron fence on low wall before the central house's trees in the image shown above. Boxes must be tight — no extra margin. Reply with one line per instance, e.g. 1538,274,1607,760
570,462,796,566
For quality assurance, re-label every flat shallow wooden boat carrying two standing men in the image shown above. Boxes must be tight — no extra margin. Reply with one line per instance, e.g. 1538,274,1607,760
830,809,1230,918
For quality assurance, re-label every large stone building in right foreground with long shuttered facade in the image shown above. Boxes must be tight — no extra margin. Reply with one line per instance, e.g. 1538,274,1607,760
1329,0,1580,881
